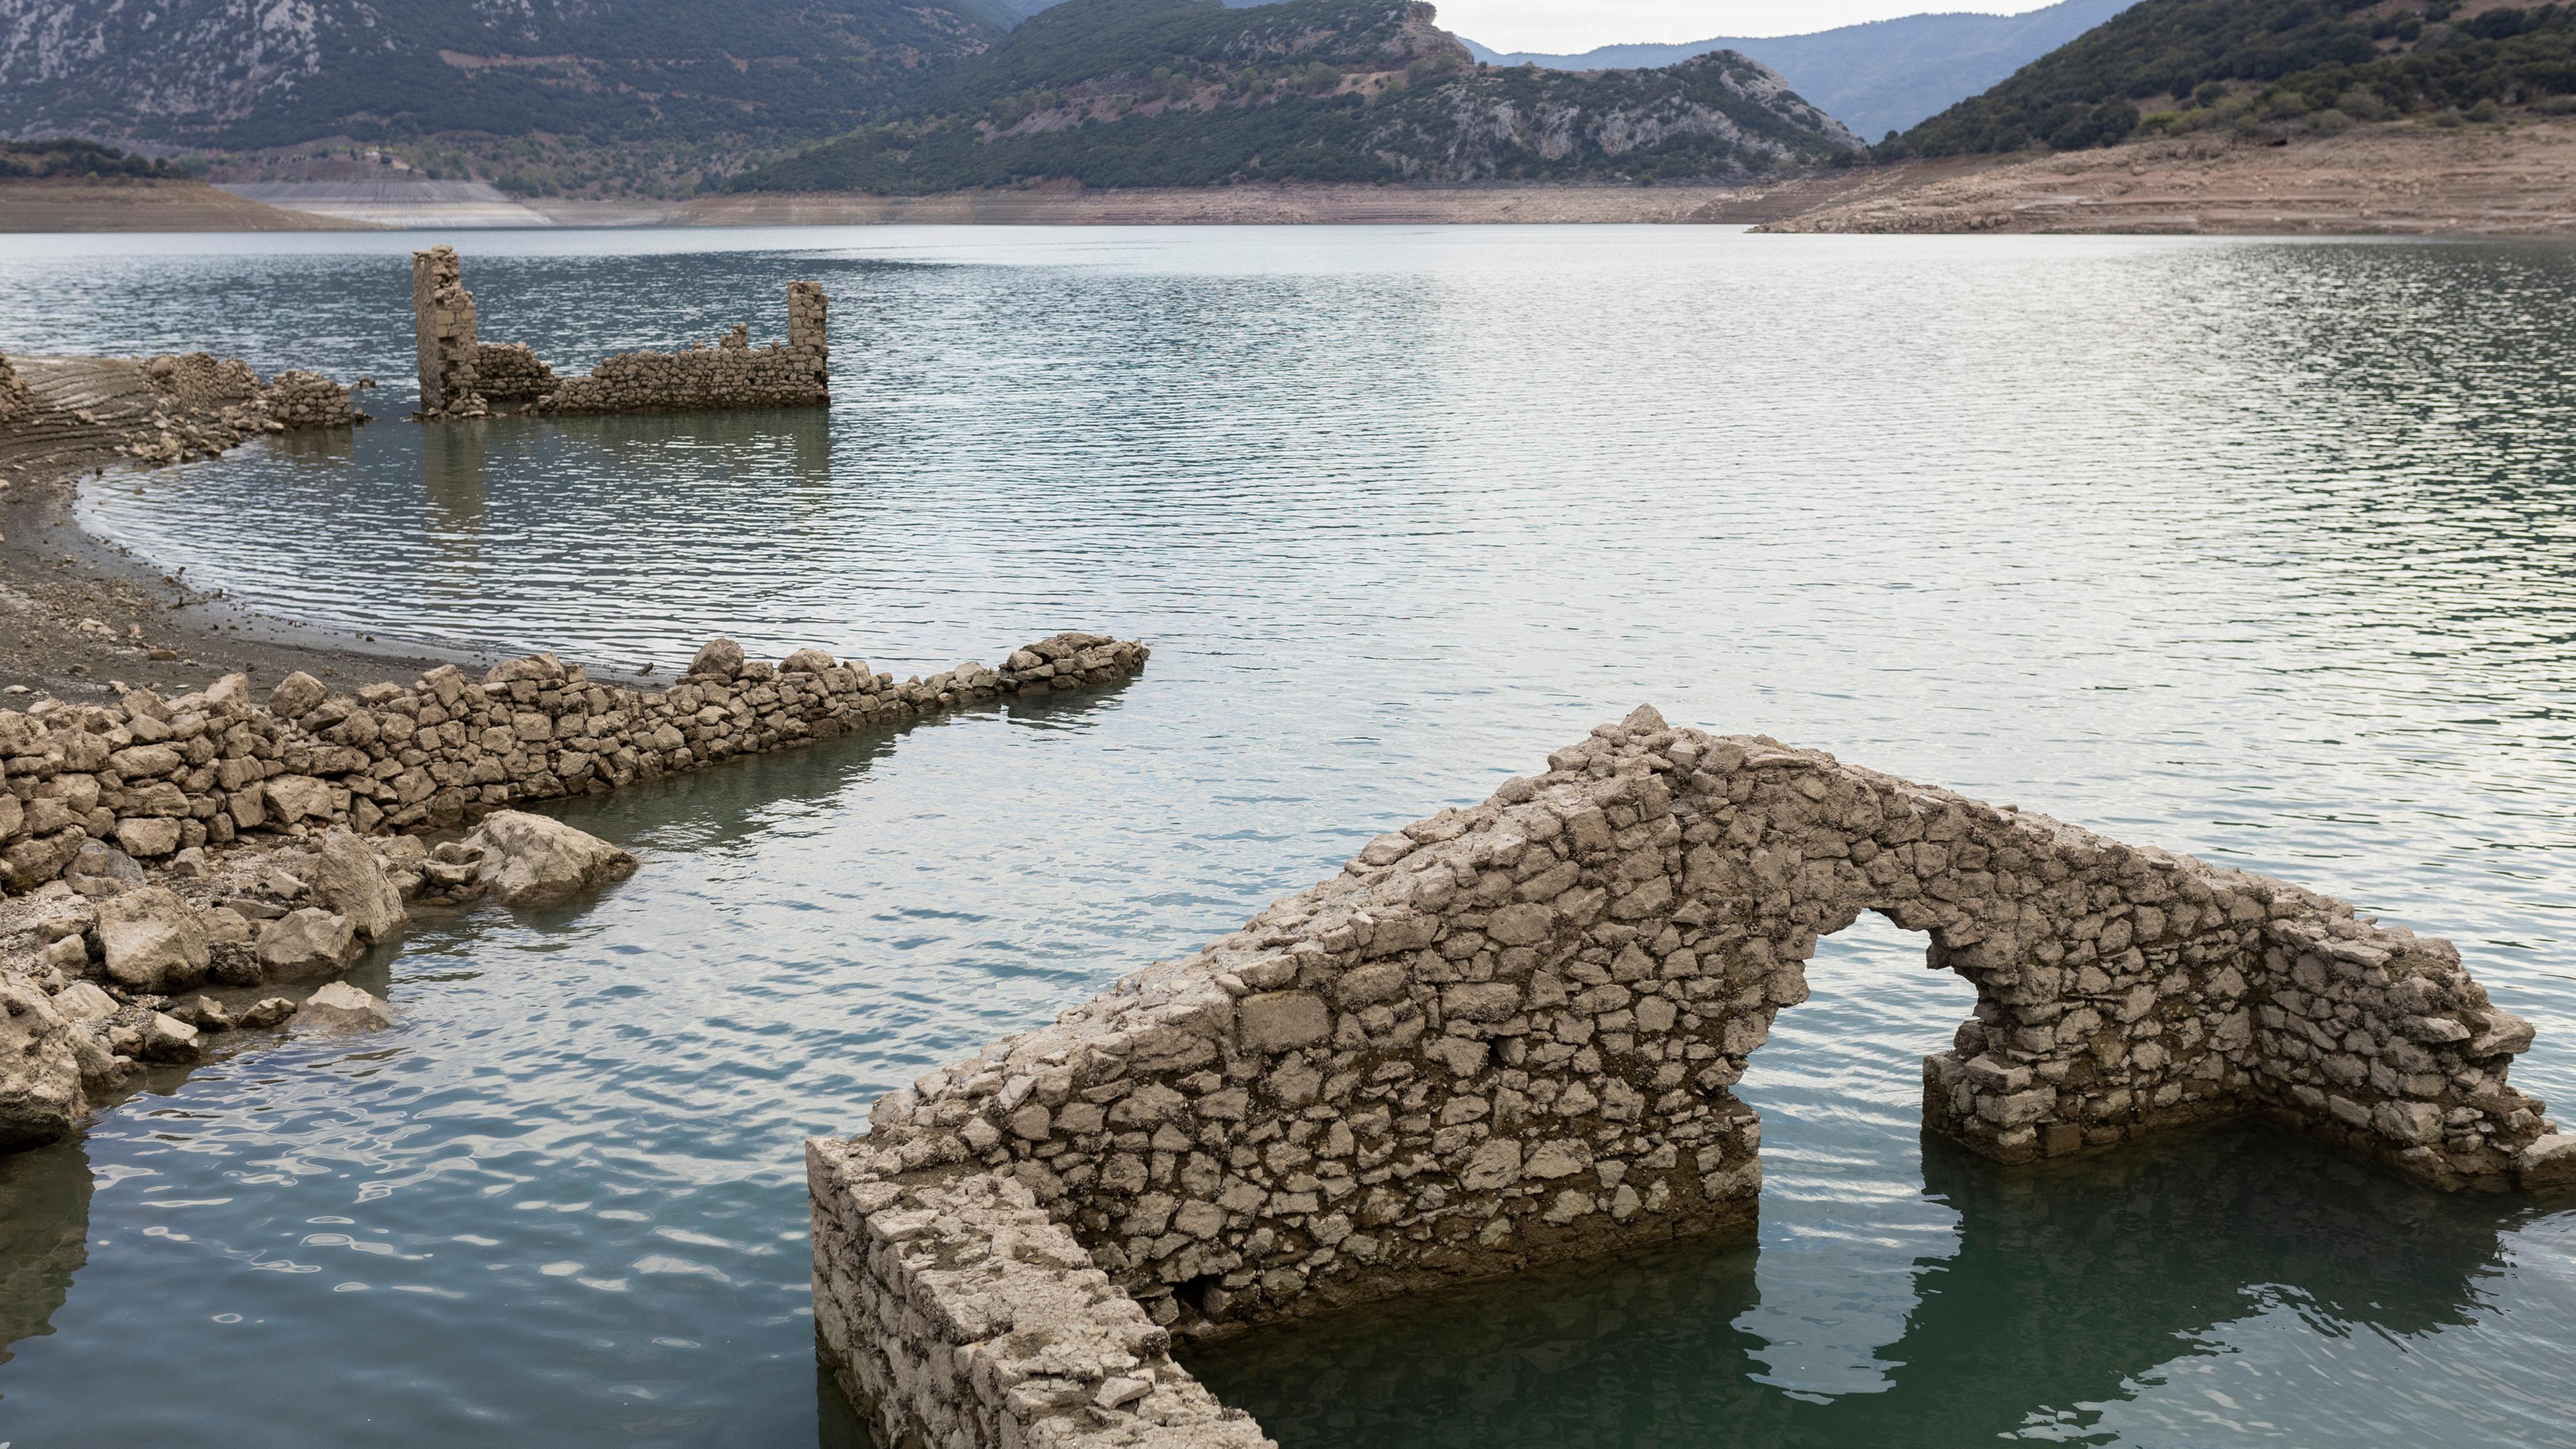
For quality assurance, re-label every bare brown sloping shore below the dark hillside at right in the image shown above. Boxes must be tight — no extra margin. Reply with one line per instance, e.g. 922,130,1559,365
1764,119,2576,237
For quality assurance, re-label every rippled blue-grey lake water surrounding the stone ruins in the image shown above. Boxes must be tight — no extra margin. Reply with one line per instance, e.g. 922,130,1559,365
0,227,2576,1449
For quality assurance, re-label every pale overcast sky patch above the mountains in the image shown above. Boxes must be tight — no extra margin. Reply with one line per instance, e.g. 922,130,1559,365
1432,0,2053,52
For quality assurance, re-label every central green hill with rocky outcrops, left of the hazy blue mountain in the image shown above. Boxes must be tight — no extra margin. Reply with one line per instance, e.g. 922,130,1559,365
729,0,1858,193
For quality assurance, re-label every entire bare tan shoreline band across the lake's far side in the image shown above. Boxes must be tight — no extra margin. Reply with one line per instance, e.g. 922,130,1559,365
0,119,2576,237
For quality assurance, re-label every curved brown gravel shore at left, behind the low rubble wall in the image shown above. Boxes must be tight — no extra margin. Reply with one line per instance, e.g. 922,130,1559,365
0,356,456,706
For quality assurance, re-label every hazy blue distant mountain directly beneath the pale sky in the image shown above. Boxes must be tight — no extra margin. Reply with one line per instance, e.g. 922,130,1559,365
1466,0,2133,137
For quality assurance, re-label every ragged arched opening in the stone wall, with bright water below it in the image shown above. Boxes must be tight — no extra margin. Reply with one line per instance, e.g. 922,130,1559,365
1733,913,1976,1397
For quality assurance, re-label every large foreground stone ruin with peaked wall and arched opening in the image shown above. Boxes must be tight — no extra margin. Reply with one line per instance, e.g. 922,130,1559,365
806,709,2576,1449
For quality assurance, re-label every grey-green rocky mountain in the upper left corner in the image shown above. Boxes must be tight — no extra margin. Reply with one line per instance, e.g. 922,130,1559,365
0,0,999,191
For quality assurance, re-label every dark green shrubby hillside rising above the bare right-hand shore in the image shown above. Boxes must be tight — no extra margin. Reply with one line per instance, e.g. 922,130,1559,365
1880,0,2576,155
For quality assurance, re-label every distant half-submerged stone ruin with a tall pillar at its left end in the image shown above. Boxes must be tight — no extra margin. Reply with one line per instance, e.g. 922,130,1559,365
412,248,832,420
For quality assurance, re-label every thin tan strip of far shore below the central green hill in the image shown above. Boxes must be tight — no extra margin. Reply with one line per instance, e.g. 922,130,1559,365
669,173,1855,227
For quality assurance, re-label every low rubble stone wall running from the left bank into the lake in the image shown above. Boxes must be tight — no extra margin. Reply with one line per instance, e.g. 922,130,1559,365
0,634,1146,892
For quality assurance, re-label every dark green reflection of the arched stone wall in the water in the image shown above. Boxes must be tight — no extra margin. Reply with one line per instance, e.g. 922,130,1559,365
1190,1127,2535,1449
